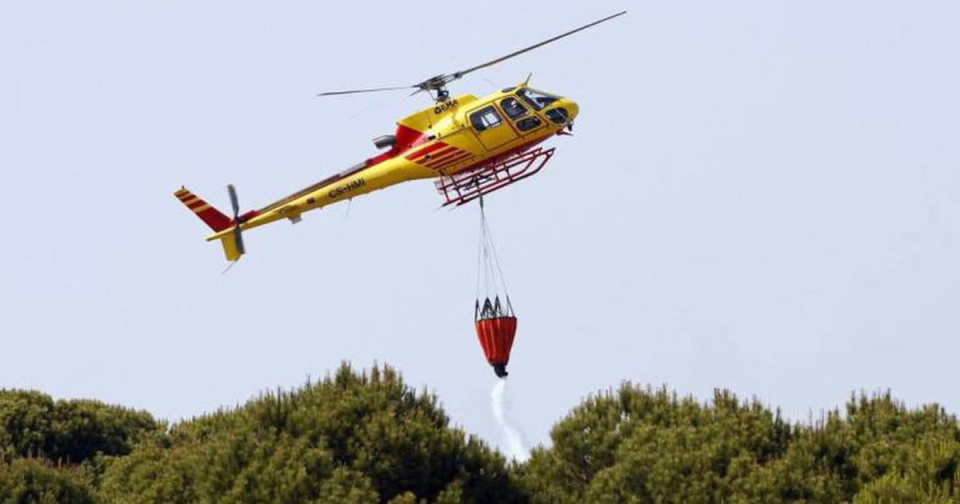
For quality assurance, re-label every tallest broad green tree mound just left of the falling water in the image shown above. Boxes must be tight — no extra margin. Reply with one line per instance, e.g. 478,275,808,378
95,366,522,503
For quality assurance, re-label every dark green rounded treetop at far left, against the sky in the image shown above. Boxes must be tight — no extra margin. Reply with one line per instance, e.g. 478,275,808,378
0,390,159,463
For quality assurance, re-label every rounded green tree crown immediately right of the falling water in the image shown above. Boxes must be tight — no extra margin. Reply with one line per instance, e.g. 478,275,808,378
524,384,792,502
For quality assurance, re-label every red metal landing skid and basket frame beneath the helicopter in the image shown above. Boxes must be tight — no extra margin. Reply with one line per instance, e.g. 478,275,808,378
435,147,555,206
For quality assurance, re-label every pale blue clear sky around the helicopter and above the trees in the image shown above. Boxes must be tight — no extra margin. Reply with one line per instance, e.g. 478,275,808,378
0,0,960,454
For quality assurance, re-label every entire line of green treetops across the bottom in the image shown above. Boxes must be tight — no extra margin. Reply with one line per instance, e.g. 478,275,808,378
0,365,960,504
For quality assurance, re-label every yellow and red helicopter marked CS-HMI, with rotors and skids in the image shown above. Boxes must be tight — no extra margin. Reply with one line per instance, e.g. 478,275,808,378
174,11,626,262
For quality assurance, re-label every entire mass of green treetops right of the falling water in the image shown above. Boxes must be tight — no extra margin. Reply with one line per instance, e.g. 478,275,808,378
519,384,960,503
